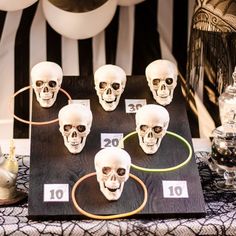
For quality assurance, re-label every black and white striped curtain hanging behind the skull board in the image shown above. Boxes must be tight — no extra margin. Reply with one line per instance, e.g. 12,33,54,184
0,0,194,138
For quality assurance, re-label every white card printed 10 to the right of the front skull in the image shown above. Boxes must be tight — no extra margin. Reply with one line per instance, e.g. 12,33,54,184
162,180,189,198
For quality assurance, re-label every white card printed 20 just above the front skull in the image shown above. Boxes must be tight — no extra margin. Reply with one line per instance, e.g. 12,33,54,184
101,133,124,148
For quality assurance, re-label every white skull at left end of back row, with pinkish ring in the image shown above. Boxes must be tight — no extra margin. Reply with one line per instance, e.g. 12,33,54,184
31,61,63,107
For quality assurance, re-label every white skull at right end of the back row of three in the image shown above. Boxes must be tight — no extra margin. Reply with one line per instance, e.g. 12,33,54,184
145,59,178,106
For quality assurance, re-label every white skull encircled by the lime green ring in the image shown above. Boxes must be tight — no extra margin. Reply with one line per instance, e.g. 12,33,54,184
135,104,170,154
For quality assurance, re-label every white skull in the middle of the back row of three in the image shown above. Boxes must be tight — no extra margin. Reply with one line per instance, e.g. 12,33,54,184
94,65,126,111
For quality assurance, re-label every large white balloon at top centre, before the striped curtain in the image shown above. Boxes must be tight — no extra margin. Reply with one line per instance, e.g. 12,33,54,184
42,0,117,39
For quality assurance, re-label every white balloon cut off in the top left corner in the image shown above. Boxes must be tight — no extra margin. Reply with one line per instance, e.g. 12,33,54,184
0,0,38,11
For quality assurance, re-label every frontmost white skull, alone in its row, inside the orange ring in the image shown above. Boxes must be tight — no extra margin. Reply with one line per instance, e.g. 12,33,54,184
94,147,131,201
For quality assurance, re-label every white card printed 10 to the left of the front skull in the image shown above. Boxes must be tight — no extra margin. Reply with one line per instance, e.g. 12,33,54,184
43,184,69,202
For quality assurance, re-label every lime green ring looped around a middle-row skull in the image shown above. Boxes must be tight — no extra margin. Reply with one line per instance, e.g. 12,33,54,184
119,131,193,172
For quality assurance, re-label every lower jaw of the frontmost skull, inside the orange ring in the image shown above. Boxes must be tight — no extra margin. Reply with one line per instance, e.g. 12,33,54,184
99,181,124,201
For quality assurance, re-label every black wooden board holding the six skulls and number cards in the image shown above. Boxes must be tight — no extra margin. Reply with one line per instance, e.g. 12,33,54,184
29,76,205,219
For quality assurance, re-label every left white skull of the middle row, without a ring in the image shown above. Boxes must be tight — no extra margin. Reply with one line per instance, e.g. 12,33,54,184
58,103,93,154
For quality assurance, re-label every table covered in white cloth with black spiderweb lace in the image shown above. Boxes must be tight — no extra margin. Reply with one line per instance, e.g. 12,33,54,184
0,139,236,235
